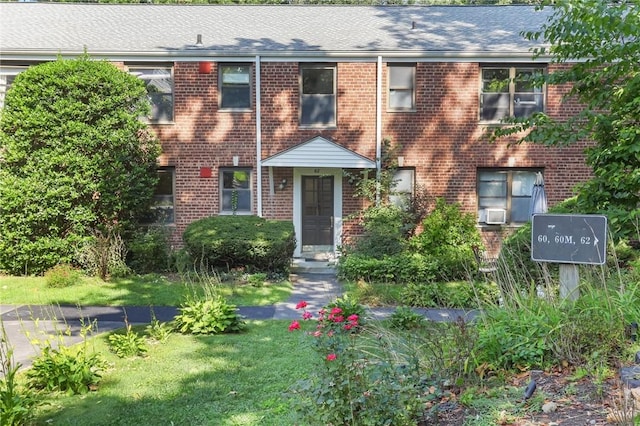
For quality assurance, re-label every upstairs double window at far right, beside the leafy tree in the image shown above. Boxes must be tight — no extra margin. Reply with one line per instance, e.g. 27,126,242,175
480,67,544,122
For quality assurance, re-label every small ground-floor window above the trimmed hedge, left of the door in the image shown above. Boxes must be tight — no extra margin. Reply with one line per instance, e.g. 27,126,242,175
220,169,252,214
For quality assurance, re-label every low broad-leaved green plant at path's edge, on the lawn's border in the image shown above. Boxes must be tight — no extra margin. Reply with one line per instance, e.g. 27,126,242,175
174,296,245,334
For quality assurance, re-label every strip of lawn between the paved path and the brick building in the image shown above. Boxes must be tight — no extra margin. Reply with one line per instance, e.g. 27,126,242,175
0,274,292,306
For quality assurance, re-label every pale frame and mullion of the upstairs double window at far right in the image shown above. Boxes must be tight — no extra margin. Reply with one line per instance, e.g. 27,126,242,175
478,65,547,123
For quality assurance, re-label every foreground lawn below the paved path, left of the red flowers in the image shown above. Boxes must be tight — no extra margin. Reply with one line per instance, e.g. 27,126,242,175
30,320,314,426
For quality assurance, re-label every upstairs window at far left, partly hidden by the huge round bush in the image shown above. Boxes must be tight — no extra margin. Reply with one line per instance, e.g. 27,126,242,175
129,66,173,123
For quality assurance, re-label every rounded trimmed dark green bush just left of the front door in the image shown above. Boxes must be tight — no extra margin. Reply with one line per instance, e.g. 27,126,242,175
183,215,296,272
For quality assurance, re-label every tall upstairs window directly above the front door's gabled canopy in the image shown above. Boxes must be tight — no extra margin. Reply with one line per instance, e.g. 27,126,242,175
300,66,336,127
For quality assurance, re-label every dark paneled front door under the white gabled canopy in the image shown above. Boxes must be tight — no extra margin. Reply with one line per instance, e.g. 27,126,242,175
302,176,333,246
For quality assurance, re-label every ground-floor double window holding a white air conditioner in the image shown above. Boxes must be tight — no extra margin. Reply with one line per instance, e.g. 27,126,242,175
477,169,542,225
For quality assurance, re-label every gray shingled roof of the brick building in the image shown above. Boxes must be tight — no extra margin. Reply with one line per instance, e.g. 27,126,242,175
0,3,549,59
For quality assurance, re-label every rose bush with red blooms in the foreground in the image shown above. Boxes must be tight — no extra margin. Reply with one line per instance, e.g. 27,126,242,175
289,300,424,426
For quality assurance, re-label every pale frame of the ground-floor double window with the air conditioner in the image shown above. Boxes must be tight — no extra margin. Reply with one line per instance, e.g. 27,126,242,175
476,168,543,226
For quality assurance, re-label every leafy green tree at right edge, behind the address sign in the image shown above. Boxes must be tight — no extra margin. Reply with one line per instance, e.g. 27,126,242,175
493,0,640,238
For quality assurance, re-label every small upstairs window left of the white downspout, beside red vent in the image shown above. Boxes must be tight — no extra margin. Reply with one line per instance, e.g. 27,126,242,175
218,64,251,110
